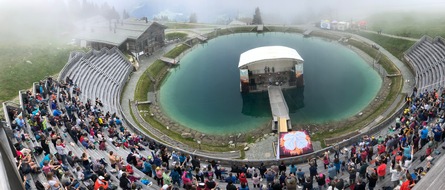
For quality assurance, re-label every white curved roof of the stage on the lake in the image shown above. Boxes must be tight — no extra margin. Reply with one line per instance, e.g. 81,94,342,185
238,46,304,68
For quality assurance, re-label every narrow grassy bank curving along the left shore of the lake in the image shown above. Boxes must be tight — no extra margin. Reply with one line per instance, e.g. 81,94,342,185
131,45,239,152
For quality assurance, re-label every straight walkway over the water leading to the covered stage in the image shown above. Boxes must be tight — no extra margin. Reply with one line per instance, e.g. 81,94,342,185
267,86,292,132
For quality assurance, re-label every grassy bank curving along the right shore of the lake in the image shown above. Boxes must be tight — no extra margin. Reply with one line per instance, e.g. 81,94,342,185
311,32,404,147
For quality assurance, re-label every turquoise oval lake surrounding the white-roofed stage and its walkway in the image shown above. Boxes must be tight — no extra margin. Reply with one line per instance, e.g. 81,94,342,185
160,33,382,134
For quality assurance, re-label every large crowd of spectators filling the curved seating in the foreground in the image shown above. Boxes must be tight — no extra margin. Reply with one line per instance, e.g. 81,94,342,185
8,73,445,190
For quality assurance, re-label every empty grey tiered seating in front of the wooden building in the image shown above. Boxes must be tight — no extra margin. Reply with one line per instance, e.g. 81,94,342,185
59,48,133,116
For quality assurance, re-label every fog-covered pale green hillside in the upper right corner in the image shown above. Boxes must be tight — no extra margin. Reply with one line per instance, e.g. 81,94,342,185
366,11,445,38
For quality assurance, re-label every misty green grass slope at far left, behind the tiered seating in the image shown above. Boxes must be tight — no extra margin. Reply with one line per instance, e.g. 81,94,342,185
0,44,74,102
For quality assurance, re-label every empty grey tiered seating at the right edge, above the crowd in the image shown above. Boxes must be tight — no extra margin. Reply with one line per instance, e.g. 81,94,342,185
405,36,445,90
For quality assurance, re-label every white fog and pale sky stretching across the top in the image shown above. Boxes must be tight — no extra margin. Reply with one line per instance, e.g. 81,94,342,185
0,0,445,43
